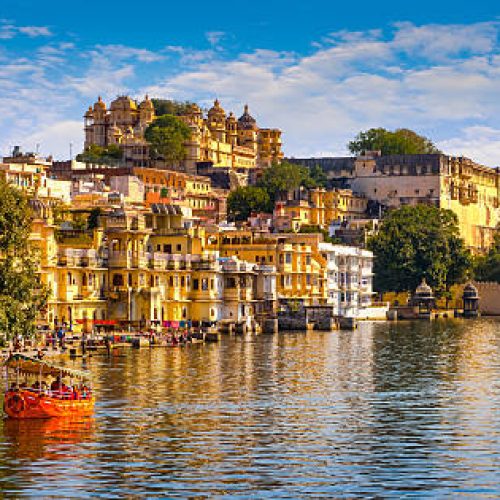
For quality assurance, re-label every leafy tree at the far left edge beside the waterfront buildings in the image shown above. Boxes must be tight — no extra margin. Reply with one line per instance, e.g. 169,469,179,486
0,180,49,339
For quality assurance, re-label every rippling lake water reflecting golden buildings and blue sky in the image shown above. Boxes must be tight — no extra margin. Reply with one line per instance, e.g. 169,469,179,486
0,319,500,498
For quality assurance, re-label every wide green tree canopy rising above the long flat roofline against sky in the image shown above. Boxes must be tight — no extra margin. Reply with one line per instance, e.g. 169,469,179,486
348,128,441,156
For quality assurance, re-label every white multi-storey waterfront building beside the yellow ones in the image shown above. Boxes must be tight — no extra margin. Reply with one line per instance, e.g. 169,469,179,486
319,243,373,318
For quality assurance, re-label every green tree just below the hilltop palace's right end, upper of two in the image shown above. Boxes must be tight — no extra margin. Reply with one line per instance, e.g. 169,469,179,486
257,161,317,200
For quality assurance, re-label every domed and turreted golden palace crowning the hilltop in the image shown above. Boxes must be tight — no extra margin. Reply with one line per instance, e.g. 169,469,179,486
84,96,283,174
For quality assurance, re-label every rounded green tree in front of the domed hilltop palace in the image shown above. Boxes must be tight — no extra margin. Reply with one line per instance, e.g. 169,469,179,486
144,115,191,164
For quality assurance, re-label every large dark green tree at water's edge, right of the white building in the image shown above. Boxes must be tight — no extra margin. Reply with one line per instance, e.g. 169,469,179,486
368,205,471,297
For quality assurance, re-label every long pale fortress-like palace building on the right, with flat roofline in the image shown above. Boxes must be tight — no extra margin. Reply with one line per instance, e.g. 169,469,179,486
290,152,500,252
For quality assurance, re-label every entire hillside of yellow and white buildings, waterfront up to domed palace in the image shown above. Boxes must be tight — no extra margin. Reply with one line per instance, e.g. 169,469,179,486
0,96,500,336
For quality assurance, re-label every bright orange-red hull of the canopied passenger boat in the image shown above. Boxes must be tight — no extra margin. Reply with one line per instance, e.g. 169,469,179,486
3,391,95,419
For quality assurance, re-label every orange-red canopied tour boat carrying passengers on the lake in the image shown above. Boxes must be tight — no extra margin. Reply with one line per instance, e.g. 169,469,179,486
3,353,95,419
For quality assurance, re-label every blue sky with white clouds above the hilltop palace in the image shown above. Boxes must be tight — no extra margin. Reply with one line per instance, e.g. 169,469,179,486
0,0,500,165
